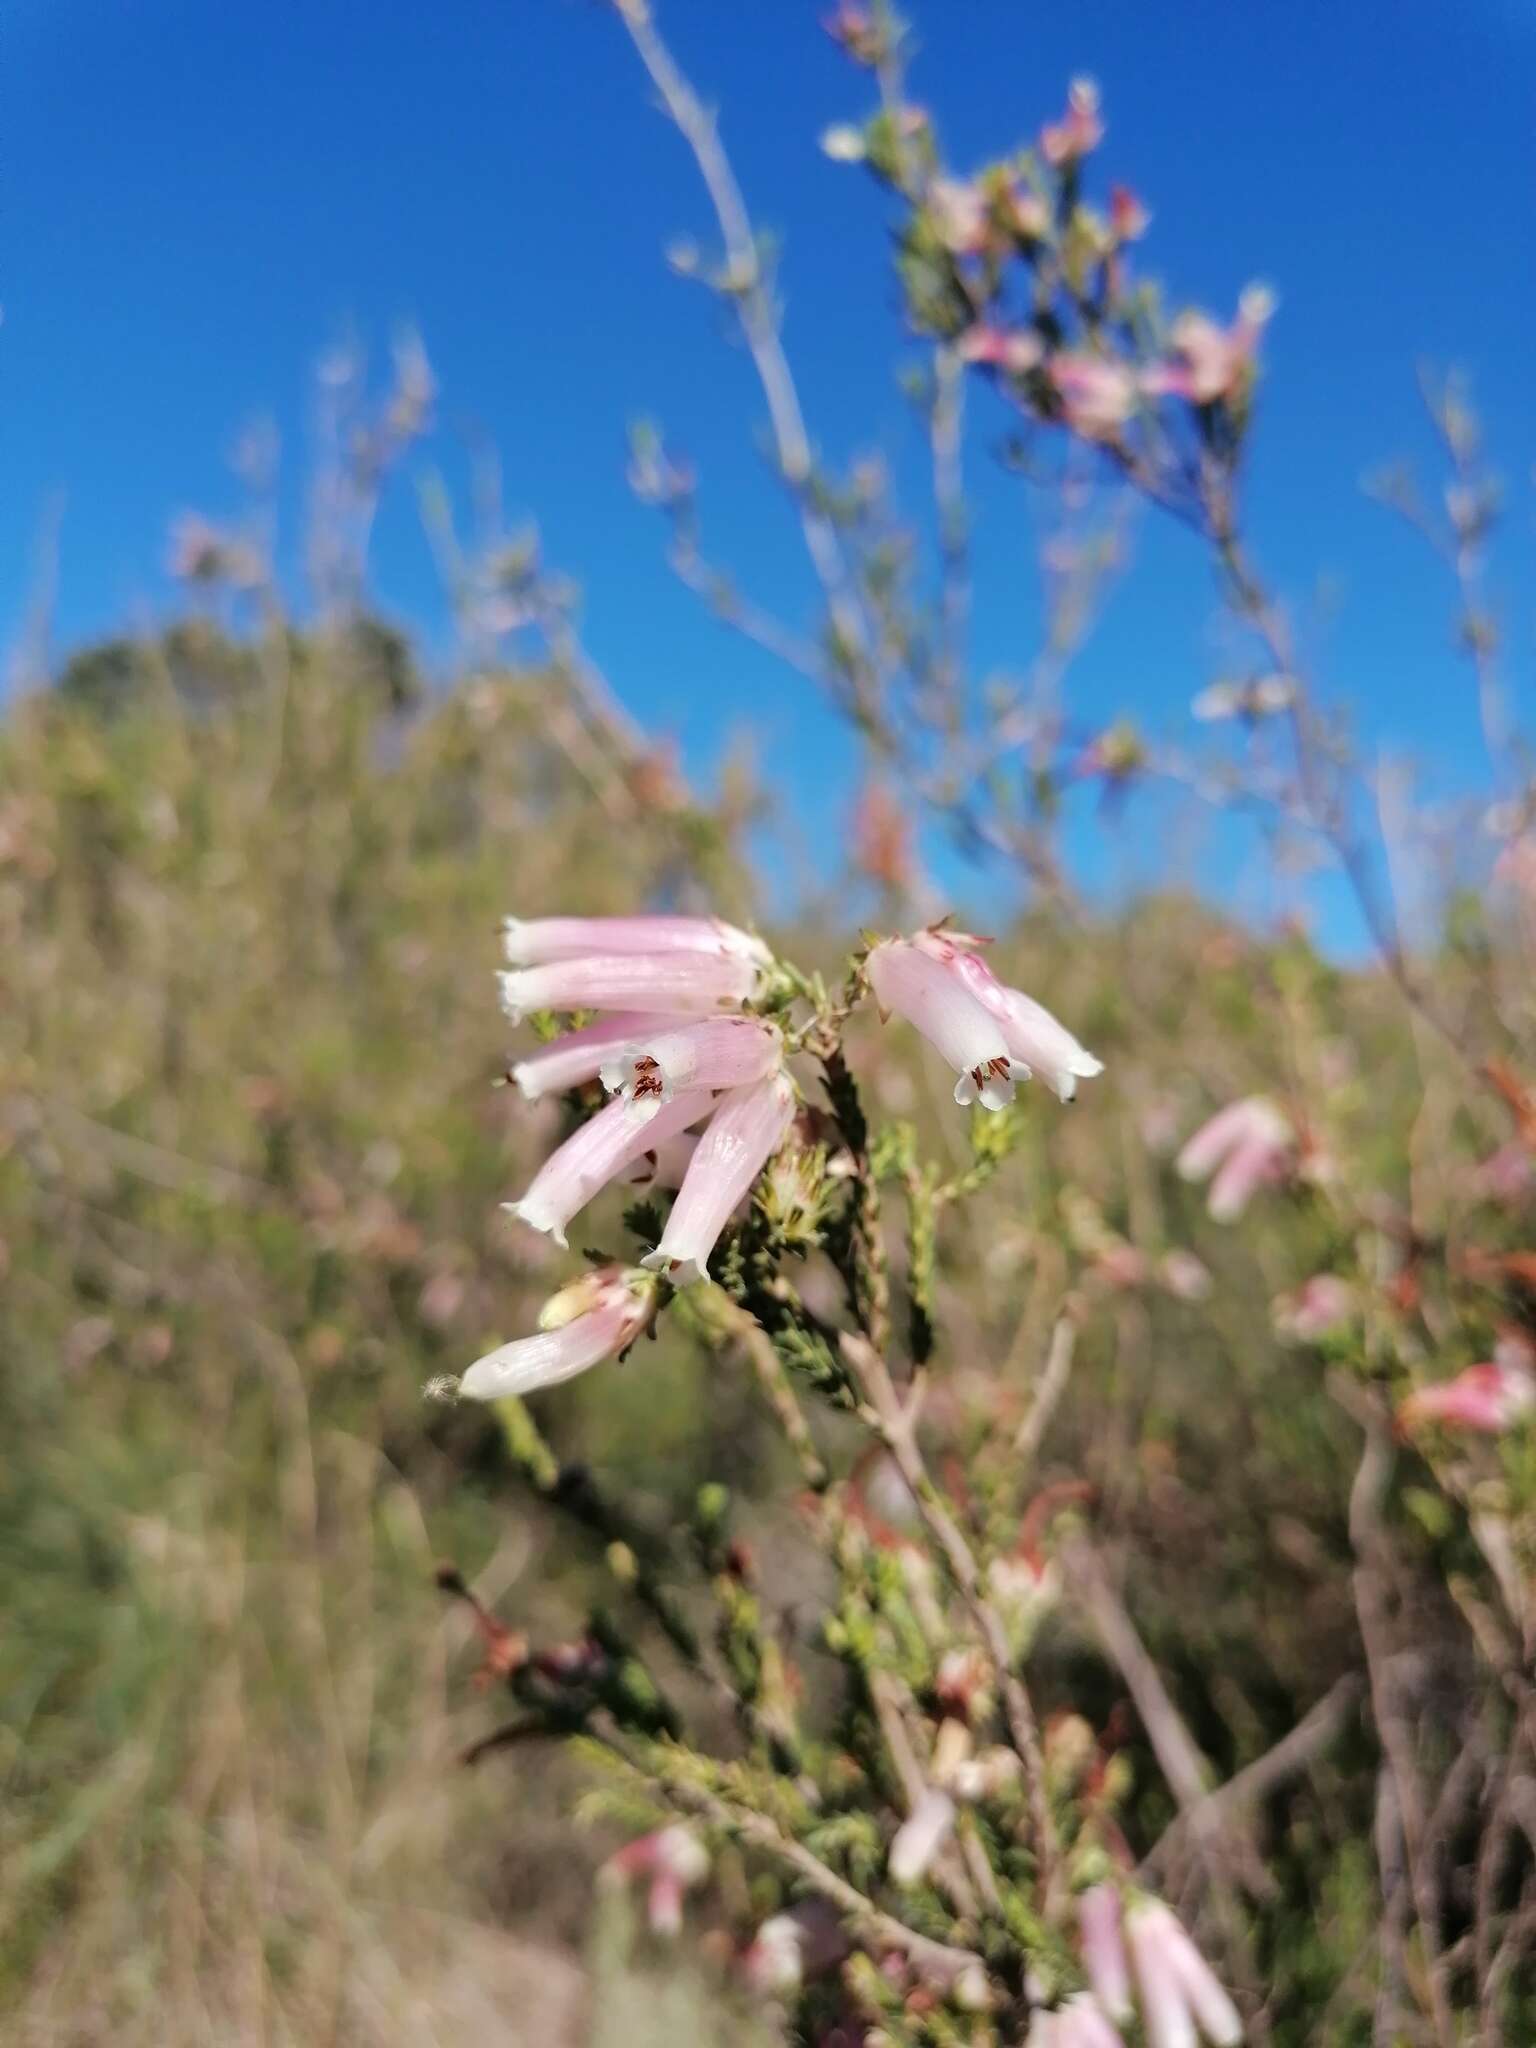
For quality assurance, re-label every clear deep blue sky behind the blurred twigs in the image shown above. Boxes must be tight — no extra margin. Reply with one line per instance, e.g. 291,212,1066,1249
0,0,1536,936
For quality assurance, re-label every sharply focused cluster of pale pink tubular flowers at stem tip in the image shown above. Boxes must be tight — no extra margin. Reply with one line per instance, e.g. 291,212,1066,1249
459,915,1102,1401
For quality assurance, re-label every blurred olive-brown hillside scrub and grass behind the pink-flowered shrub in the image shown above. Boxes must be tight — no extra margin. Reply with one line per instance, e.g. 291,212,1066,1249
0,621,1530,2048
